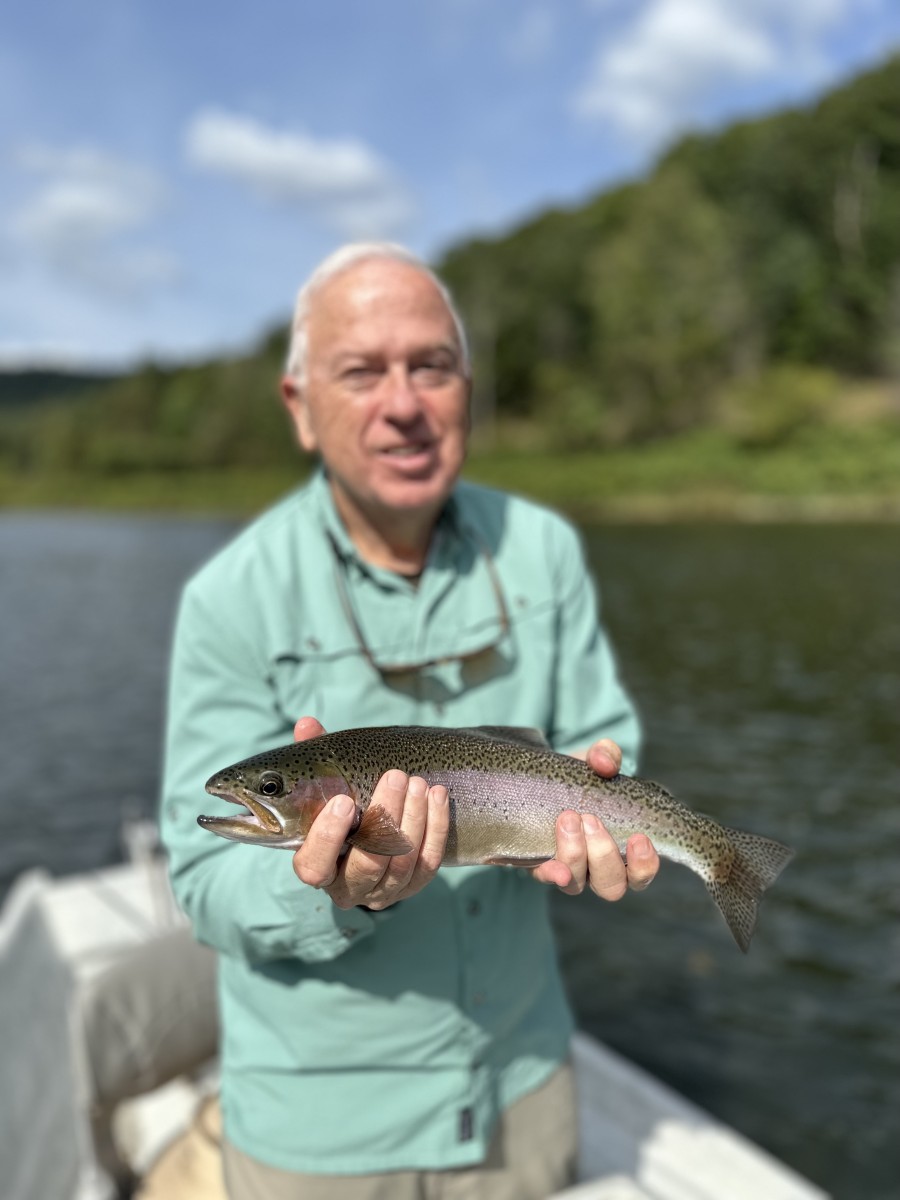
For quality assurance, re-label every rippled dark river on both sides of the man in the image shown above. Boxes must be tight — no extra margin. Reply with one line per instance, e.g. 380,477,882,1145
0,514,900,1200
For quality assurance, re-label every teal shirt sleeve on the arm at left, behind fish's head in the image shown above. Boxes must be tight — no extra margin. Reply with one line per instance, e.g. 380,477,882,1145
161,584,377,962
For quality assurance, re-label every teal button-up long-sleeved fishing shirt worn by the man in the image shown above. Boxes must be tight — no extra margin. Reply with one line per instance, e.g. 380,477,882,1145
162,474,638,1174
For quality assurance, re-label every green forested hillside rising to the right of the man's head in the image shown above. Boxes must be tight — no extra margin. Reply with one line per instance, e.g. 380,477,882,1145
442,50,900,445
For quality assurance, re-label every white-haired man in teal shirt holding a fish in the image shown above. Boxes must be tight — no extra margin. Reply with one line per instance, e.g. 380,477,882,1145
163,245,659,1200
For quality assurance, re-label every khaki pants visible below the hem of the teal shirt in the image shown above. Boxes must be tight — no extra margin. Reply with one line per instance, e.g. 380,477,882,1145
222,1066,577,1200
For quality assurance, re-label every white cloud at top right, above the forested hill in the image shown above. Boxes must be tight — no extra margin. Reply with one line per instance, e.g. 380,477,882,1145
574,0,853,149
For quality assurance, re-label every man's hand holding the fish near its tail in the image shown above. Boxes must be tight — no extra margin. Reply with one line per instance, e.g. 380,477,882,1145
532,738,659,900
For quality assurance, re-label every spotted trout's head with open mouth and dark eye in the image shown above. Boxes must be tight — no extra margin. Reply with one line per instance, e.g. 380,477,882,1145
197,755,353,850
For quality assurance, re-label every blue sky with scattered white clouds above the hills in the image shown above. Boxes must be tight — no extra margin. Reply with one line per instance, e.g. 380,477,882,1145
0,0,900,368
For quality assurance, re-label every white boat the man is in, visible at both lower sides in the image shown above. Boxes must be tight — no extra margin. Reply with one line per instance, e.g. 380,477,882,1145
0,822,827,1200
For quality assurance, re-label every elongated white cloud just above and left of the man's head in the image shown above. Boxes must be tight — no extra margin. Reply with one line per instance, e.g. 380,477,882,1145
185,109,413,238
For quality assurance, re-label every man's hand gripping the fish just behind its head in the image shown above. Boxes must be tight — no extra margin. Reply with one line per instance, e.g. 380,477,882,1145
294,716,450,908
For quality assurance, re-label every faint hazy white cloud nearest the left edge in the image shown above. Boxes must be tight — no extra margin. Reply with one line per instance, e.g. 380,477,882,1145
10,144,178,299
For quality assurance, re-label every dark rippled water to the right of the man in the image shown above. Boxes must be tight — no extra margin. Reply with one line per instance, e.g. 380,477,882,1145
556,527,900,1200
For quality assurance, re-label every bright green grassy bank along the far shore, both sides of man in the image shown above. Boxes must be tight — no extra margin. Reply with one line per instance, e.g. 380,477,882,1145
0,421,900,521
